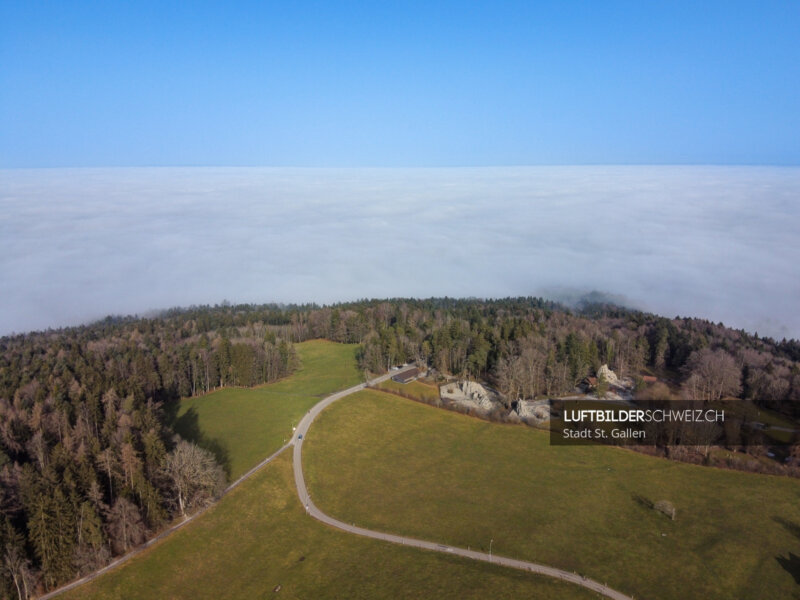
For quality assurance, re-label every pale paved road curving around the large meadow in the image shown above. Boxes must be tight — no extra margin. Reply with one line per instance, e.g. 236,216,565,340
290,370,633,600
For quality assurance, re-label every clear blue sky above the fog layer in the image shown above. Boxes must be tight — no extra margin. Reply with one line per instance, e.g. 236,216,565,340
0,0,800,167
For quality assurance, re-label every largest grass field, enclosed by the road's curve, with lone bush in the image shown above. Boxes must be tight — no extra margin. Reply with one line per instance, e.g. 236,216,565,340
303,391,800,600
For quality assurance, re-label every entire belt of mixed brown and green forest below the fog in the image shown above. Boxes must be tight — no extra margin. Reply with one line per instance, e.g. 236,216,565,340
0,298,800,598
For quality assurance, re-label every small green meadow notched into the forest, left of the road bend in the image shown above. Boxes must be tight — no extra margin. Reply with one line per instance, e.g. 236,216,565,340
173,340,363,480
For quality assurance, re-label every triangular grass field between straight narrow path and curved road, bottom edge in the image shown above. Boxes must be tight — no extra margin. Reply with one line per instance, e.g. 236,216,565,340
63,452,597,600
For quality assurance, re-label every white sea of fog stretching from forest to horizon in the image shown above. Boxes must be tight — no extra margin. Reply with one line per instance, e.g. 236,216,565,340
0,166,800,337
